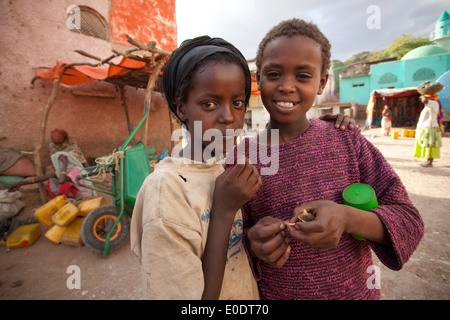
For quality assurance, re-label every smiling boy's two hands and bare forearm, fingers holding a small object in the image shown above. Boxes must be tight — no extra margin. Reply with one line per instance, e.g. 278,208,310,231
246,200,389,268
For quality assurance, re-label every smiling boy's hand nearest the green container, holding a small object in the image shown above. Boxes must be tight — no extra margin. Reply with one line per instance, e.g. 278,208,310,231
289,200,347,249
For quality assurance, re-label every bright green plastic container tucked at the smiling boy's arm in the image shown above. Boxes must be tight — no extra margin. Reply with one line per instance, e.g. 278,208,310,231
342,183,378,210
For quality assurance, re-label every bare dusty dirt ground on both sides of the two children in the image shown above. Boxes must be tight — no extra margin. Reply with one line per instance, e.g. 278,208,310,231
0,128,450,300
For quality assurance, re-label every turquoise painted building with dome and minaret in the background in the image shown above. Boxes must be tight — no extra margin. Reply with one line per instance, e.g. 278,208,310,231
339,11,450,112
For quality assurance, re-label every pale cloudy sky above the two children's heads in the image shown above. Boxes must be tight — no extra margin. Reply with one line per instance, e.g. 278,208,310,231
176,0,450,61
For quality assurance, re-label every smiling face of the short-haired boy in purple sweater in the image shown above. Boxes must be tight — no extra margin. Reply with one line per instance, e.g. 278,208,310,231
257,36,328,125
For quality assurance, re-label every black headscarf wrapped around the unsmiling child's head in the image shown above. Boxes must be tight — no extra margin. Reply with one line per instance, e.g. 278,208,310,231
163,36,251,122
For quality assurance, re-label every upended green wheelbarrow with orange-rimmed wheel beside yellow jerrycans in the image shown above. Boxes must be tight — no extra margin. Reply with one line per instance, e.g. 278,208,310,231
76,106,151,257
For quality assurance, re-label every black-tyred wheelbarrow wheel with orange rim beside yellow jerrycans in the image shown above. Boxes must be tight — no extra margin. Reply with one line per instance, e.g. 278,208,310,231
81,206,130,252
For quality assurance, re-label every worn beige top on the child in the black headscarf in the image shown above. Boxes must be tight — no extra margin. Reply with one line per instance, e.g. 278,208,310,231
131,157,259,300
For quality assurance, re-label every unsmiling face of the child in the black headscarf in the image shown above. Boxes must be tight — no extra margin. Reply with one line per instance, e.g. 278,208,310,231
177,61,245,160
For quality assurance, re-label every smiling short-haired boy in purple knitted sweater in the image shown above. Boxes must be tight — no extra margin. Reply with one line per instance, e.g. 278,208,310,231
242,19,424,299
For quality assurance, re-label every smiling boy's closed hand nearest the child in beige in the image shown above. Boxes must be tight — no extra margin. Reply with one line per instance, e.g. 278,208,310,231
247,216,291,268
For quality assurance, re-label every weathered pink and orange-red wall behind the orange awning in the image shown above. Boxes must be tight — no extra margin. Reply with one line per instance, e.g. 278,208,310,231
0,0,176,175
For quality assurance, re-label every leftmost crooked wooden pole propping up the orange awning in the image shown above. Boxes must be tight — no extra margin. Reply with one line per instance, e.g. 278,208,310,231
34,79,60,203
